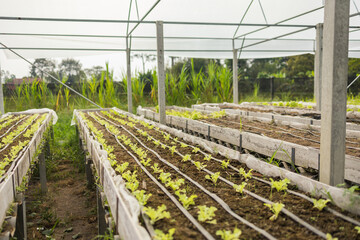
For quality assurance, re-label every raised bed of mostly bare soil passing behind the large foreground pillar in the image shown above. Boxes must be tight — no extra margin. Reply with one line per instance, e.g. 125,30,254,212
137,106,360,184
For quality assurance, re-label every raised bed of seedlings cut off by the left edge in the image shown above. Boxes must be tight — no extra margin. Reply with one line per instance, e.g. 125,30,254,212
0,110,55,236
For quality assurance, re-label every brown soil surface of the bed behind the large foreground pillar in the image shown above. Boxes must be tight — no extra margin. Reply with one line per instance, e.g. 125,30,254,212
201,116,360,157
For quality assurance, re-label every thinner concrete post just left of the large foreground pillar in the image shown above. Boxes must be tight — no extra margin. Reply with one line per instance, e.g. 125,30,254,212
314,23,324,111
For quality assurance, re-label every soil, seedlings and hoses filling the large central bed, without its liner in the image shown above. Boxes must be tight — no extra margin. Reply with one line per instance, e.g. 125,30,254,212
81,110,360,239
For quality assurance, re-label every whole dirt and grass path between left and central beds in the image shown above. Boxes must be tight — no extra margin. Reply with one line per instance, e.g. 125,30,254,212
25,114,97,240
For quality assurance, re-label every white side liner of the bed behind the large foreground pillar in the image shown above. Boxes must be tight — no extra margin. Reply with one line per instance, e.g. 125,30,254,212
137,107,360,186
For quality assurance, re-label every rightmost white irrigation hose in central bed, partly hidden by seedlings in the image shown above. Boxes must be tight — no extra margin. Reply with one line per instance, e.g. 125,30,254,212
128,108,360,226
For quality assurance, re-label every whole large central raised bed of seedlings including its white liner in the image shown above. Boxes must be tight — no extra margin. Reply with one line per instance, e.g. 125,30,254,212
75,109,360,239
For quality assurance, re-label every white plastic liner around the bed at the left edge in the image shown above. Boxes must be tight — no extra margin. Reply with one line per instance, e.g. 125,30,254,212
0,109,57,229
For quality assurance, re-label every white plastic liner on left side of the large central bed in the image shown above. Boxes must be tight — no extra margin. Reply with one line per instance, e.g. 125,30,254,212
74,109,151,240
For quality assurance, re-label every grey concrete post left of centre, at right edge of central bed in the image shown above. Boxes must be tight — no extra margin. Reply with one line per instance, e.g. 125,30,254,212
156,21,166,124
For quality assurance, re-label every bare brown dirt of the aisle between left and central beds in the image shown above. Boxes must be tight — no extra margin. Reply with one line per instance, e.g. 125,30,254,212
26,159,97,240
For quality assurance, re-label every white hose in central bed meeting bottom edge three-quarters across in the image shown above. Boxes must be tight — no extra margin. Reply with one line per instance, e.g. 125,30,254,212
93,114,276,240
